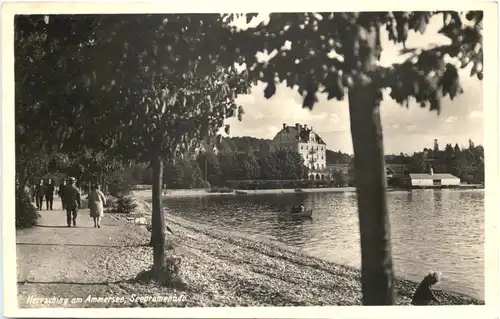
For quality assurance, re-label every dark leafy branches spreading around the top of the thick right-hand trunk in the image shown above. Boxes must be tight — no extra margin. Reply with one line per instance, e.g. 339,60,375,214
221,11,483,111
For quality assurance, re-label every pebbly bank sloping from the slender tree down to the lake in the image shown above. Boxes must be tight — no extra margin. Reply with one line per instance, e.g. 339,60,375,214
106,198,484,307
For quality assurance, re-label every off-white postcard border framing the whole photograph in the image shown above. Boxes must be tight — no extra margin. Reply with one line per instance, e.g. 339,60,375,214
0,0,499,318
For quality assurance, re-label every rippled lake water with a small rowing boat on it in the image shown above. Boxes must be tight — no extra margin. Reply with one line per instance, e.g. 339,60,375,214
166,190,484,300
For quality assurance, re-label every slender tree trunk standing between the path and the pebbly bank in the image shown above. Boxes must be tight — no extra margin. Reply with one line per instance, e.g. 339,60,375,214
151,157,165,278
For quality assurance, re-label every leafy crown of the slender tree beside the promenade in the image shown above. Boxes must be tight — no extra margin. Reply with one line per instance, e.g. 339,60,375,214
84,15,252,161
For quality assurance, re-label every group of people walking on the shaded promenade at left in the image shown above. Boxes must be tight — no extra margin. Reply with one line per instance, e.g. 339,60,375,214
32,177,106,228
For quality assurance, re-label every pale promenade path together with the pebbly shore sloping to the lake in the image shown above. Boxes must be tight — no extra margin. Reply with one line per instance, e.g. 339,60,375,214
17,201,484,307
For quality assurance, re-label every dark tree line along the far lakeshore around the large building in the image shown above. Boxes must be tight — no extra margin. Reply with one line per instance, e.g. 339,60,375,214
132,137,484,189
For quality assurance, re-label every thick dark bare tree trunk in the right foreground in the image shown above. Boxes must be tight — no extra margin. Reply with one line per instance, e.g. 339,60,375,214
349,85,394,305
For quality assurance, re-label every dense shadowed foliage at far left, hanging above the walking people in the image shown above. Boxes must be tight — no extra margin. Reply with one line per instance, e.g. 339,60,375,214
14,15,125,190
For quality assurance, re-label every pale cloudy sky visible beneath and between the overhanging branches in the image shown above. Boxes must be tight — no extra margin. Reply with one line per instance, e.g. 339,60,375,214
220,15,483,154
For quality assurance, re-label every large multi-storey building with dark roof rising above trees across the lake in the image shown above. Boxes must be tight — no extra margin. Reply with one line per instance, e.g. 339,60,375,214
271,123,327,179
